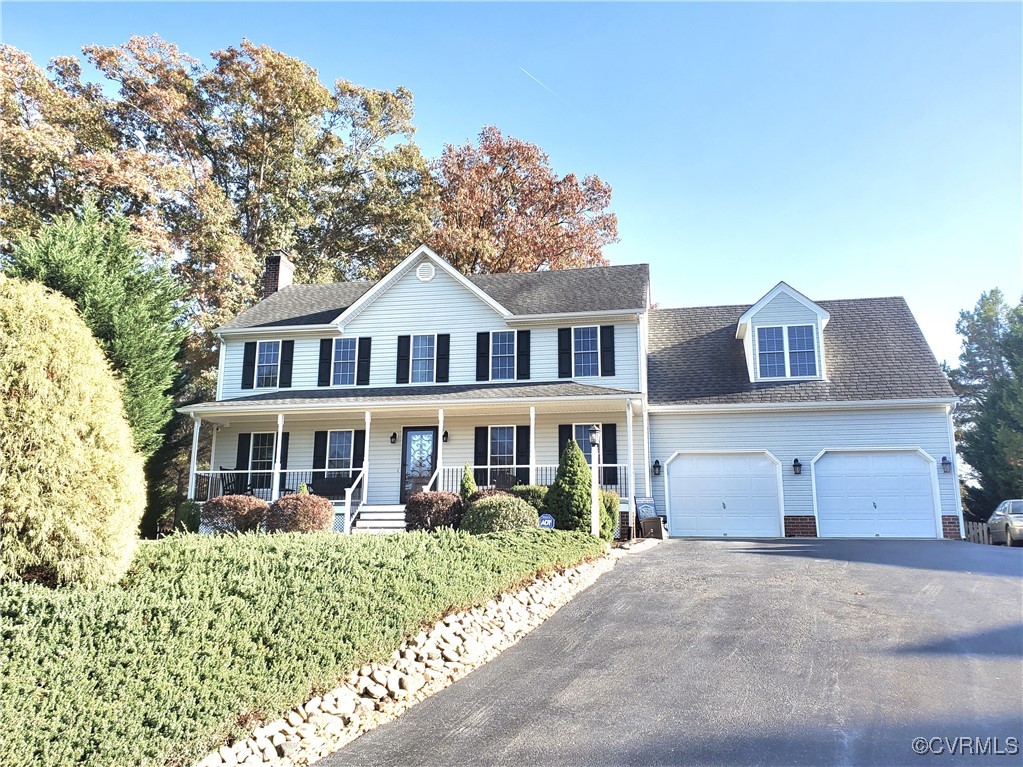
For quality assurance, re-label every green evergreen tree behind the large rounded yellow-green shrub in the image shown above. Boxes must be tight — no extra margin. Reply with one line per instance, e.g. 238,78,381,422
5,202,187,457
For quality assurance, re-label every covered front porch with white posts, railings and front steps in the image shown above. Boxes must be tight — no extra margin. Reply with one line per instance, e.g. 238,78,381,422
188,397,650,533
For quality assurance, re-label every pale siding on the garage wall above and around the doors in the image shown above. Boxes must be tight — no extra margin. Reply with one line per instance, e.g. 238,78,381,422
646,406,959,515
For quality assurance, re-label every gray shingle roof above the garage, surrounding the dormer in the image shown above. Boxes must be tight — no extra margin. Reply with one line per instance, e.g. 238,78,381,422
648,298,954,405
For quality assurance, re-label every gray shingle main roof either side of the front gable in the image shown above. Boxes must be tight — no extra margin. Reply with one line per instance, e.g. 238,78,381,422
222,264,650,329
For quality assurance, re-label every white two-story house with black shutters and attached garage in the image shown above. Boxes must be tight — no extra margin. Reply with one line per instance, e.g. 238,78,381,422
183,247,962,538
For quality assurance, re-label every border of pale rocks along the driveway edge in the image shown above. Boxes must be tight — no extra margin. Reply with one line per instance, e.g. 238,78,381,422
196,549,626,767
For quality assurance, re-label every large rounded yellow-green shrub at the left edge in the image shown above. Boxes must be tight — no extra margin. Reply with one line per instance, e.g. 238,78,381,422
0,274,145,584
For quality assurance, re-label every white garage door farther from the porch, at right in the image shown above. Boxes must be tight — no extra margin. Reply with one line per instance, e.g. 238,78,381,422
813,451,938,538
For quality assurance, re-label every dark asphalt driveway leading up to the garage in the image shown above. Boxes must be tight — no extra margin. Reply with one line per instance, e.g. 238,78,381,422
321,540,1023,767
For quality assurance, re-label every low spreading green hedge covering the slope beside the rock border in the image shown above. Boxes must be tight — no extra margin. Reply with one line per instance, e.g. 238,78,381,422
0,529,603,767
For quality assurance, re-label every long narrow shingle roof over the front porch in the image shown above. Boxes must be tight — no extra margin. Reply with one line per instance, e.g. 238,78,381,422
190,381,639,409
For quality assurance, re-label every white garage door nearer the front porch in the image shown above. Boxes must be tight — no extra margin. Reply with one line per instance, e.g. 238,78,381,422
668,453,782,538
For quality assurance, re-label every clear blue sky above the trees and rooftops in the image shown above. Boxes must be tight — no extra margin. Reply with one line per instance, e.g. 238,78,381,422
0,0,1023,361
